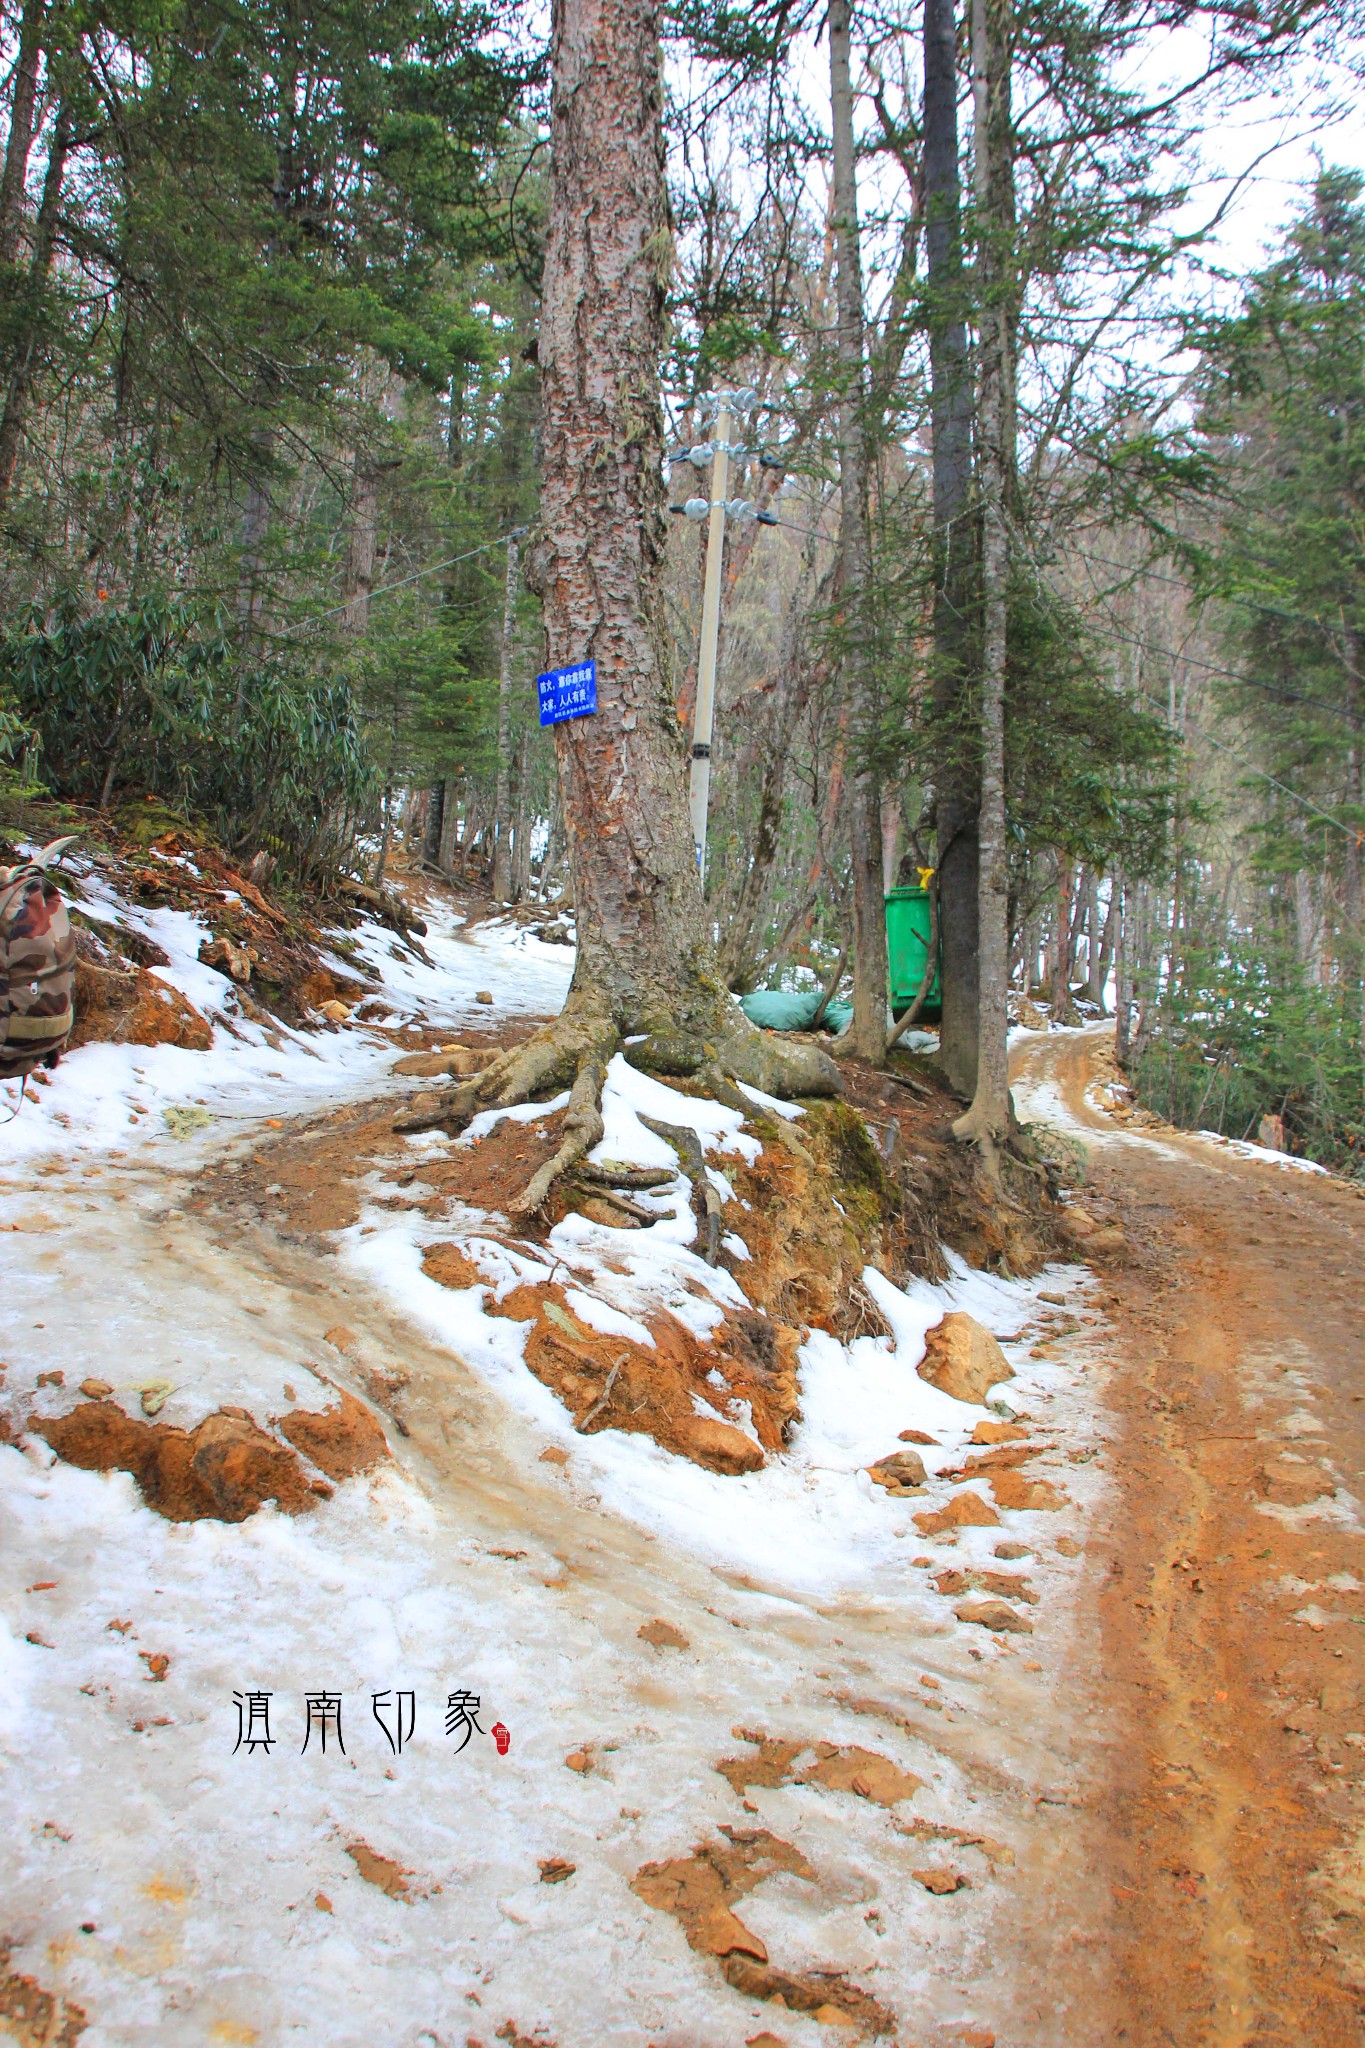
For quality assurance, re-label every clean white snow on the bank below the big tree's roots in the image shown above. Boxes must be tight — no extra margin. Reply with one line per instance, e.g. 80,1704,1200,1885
342,1055,1074,1591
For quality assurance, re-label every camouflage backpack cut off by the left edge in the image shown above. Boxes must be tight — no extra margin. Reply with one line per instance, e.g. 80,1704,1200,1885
0,836,76,1081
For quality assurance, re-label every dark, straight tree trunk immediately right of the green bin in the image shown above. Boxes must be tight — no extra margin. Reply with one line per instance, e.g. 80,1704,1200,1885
925,0,978,1096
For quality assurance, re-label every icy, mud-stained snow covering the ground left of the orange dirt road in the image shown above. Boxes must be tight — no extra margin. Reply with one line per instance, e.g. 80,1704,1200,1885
0,872,1103,2048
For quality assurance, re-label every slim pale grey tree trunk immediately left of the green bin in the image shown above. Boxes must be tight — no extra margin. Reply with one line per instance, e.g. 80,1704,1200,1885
829,0,886,1067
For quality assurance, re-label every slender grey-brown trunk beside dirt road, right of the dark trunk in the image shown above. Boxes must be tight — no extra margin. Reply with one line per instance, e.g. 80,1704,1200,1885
954,0,1015,1161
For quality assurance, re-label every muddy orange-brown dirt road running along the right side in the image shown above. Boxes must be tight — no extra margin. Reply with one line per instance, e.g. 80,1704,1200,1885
1015,1032,1365,2048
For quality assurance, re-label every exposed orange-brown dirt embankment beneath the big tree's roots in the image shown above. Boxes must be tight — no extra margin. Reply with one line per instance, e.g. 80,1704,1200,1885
181,1026,1056,1483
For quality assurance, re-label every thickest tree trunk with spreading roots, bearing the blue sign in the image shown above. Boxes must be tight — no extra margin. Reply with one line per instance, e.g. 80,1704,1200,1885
399,0,839,1212
